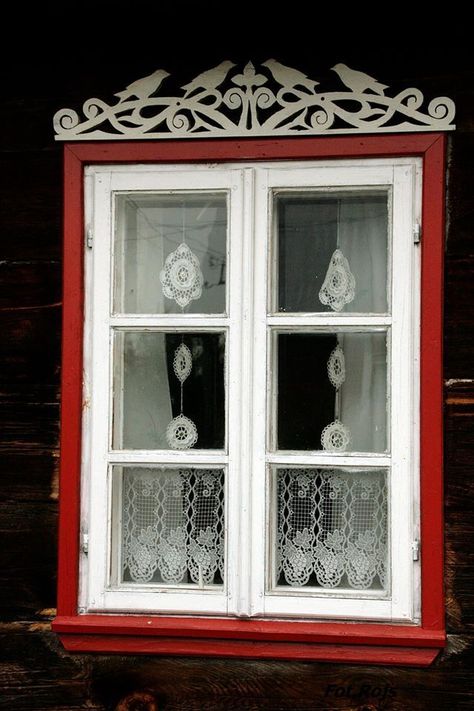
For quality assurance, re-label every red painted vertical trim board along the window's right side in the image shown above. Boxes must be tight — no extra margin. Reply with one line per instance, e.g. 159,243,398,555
420,135,446,629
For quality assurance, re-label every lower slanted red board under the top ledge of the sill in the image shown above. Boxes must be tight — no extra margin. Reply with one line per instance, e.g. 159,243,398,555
60,635,439,667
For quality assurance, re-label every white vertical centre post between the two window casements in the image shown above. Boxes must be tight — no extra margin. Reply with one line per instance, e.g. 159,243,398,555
240,168,268,616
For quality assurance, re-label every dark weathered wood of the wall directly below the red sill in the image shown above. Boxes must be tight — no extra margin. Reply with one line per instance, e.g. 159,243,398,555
0,623,474,711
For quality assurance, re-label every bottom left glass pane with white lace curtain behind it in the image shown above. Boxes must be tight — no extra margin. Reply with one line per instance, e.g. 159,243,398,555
113,467,225,587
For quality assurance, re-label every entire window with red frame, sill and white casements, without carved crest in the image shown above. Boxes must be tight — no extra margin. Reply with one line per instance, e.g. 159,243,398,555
55,136,444,663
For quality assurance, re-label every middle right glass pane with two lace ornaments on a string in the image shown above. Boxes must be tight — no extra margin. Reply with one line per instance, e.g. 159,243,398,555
273,329,388,452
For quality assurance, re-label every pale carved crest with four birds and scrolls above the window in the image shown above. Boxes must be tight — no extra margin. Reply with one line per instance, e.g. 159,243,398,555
54,59,455,141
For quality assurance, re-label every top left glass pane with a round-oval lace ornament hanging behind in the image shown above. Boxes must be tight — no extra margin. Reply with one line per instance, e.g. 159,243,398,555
114,193,227,314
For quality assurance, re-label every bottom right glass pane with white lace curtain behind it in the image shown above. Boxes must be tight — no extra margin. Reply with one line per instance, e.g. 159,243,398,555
274,468,389,591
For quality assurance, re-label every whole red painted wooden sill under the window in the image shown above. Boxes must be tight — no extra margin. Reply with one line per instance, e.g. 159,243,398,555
52,615,446,667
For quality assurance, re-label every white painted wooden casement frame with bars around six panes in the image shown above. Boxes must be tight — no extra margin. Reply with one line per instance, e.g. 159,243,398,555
79,157,422,623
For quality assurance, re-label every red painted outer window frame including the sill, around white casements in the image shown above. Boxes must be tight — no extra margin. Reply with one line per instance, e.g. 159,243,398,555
52,133,446,666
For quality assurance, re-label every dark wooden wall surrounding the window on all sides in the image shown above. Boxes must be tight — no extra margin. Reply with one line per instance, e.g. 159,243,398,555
0,2,474,711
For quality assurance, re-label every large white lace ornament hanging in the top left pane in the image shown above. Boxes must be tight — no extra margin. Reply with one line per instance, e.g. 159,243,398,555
160,242,204,308
